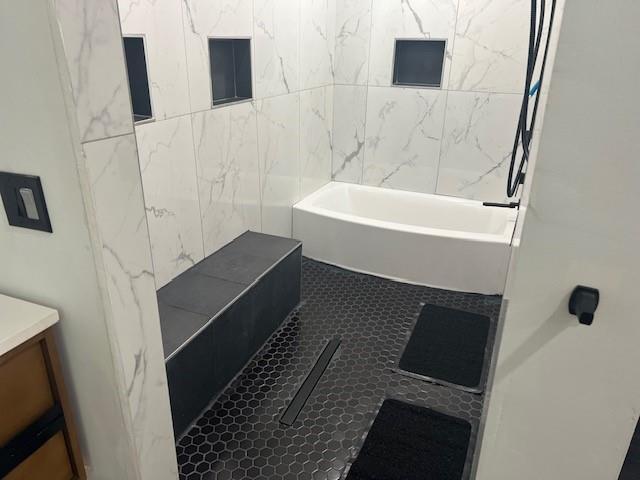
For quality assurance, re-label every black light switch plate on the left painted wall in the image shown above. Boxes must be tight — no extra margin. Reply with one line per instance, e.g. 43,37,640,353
0,172,53,232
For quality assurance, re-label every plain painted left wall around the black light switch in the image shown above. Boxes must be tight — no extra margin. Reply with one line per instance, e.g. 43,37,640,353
0,0,138,480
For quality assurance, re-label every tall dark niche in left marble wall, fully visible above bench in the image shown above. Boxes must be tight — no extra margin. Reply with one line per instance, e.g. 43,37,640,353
209,38,252,106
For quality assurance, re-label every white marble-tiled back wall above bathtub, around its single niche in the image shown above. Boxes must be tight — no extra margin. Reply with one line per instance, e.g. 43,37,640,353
332,0,562,201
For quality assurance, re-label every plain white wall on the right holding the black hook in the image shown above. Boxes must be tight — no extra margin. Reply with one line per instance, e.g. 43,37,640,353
477,0,640,480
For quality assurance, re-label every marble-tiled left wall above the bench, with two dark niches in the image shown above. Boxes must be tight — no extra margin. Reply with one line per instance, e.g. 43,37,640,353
119,0,335,288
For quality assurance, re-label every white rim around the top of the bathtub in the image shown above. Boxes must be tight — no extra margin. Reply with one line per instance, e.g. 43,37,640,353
293,181,518,245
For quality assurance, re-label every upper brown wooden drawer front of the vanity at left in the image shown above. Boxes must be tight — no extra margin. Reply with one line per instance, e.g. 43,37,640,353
0,342,54,447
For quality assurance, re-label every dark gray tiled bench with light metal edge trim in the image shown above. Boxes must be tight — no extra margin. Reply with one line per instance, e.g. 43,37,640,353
158,232,302,438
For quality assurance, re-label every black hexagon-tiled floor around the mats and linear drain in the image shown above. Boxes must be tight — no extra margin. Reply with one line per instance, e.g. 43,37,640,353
177,259,500,480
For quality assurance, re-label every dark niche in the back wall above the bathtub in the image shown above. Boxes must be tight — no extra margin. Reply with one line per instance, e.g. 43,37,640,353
393,40,447,88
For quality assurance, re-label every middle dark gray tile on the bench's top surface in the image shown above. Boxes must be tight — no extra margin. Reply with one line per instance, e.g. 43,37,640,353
158,269,246,318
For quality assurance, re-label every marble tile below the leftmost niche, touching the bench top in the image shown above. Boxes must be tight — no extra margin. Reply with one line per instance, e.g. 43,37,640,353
136,116,204,288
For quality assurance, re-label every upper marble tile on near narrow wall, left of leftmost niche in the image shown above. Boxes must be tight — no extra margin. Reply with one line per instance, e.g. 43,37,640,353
55,0,133,142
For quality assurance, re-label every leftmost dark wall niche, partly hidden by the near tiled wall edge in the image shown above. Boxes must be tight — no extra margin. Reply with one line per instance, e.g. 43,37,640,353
123,37,153,122
